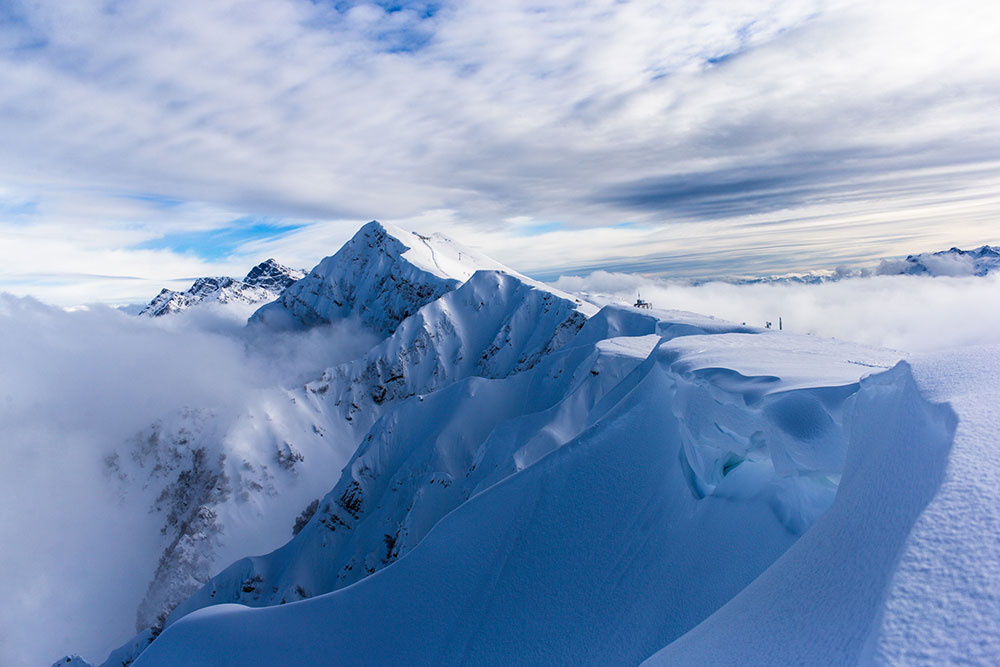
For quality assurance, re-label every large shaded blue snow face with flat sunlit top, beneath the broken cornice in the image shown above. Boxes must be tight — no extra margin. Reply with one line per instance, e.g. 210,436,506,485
129,309,912,665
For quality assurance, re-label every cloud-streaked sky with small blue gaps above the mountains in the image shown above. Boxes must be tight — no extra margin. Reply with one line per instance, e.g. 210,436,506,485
0,0,1000,305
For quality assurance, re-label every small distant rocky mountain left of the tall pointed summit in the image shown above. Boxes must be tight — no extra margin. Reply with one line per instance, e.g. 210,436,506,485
139,259,305,317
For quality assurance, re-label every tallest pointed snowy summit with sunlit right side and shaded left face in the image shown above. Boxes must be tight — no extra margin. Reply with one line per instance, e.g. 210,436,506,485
251,220,516,335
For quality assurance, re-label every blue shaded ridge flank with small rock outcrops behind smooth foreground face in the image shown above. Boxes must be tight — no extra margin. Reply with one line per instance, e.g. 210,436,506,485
162,337,656,619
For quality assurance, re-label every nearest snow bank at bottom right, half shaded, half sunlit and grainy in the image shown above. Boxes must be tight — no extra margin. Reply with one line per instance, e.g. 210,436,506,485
649,346,1000,665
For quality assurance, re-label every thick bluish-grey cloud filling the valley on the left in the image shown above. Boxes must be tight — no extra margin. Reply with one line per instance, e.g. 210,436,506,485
0,293,374,665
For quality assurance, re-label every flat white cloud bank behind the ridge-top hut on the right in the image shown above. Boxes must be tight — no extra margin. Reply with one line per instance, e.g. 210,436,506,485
554,271,1000,352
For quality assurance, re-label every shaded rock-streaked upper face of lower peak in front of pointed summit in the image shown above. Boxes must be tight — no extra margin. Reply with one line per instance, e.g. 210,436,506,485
307,271,594,428
